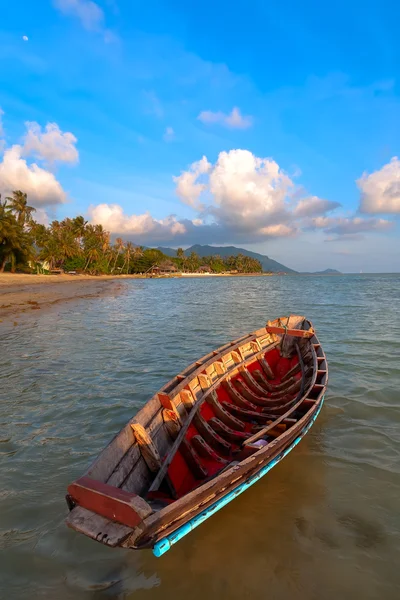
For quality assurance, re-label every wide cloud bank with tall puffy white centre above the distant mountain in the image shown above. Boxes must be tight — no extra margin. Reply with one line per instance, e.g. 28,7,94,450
84,149,394,245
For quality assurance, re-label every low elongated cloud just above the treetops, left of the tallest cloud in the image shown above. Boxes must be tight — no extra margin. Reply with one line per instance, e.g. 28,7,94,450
88,204,186,242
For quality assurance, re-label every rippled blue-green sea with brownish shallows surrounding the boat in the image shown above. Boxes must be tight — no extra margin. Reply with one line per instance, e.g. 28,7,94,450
0,274,400,600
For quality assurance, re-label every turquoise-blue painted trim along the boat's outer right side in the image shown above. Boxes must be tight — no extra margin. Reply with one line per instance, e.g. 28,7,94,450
153,396,324,557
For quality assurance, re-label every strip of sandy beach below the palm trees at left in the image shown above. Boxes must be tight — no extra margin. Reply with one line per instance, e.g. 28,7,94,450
0,273,125,321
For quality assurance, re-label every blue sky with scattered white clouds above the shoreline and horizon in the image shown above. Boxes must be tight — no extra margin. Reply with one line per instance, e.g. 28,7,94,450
0,0,400,271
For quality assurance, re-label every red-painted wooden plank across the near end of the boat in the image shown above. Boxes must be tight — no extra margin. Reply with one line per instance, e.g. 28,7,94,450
68,476,153,527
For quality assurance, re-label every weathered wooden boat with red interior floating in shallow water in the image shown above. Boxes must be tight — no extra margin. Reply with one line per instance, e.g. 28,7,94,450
67,315,328,556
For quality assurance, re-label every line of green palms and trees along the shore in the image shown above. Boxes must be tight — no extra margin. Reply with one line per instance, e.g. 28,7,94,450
0,190,262,275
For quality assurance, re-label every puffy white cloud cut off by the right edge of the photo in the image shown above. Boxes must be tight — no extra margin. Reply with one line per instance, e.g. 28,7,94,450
357,156,400,214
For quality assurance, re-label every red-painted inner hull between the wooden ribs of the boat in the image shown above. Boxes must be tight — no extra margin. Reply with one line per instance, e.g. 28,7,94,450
153,347,301,503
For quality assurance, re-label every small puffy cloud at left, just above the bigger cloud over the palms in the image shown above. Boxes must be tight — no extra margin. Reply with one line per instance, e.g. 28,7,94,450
22,121,79,164
